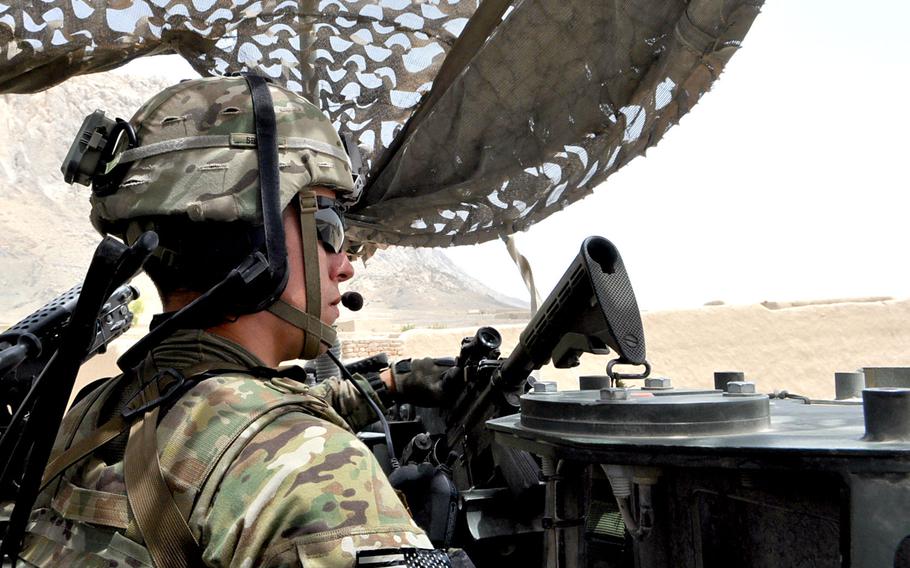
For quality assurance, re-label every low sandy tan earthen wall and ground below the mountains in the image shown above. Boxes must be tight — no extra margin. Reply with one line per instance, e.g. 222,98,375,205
64,299,910,398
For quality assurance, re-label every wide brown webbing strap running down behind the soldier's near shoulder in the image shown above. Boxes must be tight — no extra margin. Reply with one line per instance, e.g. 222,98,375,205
123,382,202,568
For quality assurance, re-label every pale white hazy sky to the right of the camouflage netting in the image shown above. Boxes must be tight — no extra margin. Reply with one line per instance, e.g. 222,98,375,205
123,0,910,310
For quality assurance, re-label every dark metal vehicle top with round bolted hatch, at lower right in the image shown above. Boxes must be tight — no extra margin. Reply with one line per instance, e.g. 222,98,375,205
487,389,910,568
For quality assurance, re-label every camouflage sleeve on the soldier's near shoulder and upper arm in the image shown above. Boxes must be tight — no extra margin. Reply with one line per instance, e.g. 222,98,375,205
202,412,432,568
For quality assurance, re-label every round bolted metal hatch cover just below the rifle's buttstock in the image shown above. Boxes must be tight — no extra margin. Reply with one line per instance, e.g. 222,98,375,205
521,390,771,436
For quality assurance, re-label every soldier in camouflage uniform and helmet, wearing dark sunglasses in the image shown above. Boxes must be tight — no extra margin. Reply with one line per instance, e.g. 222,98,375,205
21,77,464,567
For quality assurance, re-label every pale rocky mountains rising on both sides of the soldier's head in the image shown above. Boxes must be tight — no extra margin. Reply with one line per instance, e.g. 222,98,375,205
0,73,522,324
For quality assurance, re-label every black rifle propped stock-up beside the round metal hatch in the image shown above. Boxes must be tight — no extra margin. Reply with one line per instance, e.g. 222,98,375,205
446,237,646,489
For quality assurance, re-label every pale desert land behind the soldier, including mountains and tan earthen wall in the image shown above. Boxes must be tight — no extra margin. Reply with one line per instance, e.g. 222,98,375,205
0,69,910,398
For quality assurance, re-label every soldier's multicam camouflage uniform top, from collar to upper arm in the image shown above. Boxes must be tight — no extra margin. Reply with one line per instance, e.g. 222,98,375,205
21,331,432,567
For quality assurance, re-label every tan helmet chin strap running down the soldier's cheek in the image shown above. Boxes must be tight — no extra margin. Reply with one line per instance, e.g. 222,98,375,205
266,190,337,359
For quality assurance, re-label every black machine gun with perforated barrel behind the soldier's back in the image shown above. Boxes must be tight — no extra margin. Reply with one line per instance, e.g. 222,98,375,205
0,284,139,434
